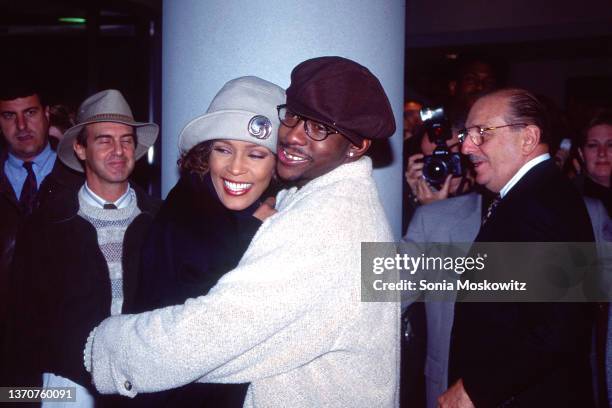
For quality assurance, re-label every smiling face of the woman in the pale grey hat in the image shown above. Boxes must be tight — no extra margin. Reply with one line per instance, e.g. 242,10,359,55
208,139,276,211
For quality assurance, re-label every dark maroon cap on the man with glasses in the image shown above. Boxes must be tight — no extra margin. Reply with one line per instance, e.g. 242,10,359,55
287,57,395,145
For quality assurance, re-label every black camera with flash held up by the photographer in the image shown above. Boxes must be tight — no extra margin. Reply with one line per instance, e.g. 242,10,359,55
420,107,466,188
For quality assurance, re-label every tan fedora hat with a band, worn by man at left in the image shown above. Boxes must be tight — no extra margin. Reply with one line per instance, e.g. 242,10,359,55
57,89,159,172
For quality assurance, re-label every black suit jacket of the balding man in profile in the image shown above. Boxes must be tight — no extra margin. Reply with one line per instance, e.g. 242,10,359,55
449,160,594,408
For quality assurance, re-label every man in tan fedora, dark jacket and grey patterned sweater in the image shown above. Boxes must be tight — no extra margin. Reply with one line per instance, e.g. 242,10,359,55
7,89,158,407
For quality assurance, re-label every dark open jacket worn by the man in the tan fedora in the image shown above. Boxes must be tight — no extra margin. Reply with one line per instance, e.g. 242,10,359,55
5,182,160,392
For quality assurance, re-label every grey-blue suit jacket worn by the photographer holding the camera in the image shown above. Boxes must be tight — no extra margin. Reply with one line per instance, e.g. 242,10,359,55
402,193,482,408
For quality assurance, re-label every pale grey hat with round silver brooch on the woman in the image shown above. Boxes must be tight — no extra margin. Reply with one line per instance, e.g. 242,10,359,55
179,76,285,154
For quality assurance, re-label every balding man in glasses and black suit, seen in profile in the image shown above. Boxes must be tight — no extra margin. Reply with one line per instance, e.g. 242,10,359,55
439,89,593,407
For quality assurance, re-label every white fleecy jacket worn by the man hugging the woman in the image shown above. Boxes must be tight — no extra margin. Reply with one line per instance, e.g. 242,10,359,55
85,157,400,408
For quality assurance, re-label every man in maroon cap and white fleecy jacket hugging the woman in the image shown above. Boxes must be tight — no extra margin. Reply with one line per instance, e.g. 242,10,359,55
85,57,400,408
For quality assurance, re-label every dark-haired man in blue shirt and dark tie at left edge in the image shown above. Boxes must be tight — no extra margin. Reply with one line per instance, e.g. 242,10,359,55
0,77,82,360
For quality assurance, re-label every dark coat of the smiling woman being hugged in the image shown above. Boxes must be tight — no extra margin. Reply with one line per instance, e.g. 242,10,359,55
126,174,261,407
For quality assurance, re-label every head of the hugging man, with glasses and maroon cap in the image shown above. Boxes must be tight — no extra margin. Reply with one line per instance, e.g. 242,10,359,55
277,57,395,187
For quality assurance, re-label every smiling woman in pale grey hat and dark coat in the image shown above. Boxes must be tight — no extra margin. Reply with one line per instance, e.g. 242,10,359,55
129,76,285,407
